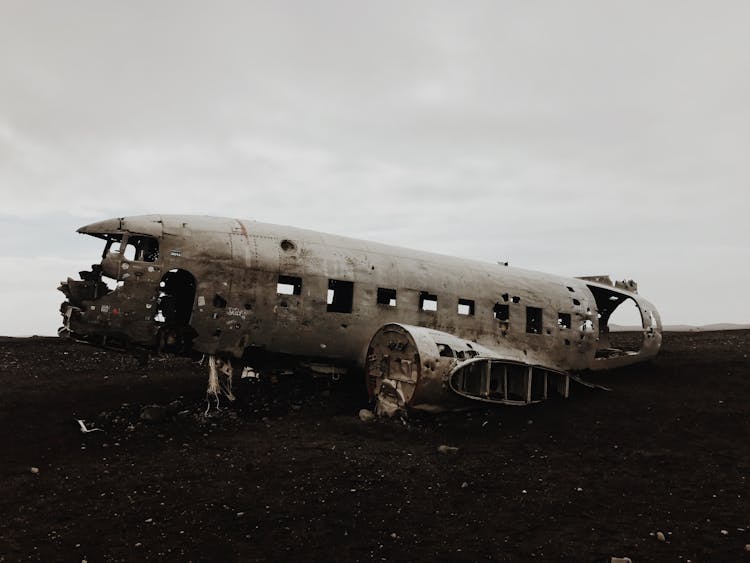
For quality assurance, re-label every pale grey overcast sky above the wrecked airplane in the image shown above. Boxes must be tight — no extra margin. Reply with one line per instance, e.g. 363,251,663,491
0,0,750,335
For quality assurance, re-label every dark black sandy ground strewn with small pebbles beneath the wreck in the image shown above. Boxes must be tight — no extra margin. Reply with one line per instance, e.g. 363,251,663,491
0,331,750,561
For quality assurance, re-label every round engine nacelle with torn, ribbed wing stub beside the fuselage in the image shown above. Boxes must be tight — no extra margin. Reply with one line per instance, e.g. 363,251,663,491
365,324,570,416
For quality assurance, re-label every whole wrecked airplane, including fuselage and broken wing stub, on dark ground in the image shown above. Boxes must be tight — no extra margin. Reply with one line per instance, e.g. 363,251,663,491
60,215,662,414
